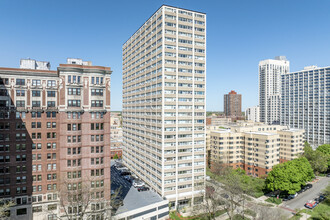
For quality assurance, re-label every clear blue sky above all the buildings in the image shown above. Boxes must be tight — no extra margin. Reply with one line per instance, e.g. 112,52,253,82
0,0,330,111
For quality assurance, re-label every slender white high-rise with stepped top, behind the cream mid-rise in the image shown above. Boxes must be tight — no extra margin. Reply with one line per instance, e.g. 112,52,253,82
259,56,290,124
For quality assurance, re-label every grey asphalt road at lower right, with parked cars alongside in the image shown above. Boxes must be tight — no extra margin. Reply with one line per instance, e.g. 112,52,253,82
282,177,330,210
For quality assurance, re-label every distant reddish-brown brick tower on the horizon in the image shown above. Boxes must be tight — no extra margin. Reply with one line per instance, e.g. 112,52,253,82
223,90,242,117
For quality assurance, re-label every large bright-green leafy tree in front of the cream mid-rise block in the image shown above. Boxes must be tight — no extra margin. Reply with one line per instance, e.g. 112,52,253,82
266,157,314,194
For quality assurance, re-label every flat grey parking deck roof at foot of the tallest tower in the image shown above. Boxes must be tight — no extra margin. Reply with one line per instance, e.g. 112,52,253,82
116,187,164,215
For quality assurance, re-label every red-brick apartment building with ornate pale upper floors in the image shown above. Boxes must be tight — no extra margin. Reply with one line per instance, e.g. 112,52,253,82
0,59,111,219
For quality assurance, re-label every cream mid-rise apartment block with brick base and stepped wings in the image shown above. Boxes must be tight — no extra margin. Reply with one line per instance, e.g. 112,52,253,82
207,122,304,177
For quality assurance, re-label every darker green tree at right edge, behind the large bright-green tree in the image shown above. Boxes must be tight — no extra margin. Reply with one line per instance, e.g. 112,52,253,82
304,143,330,175
